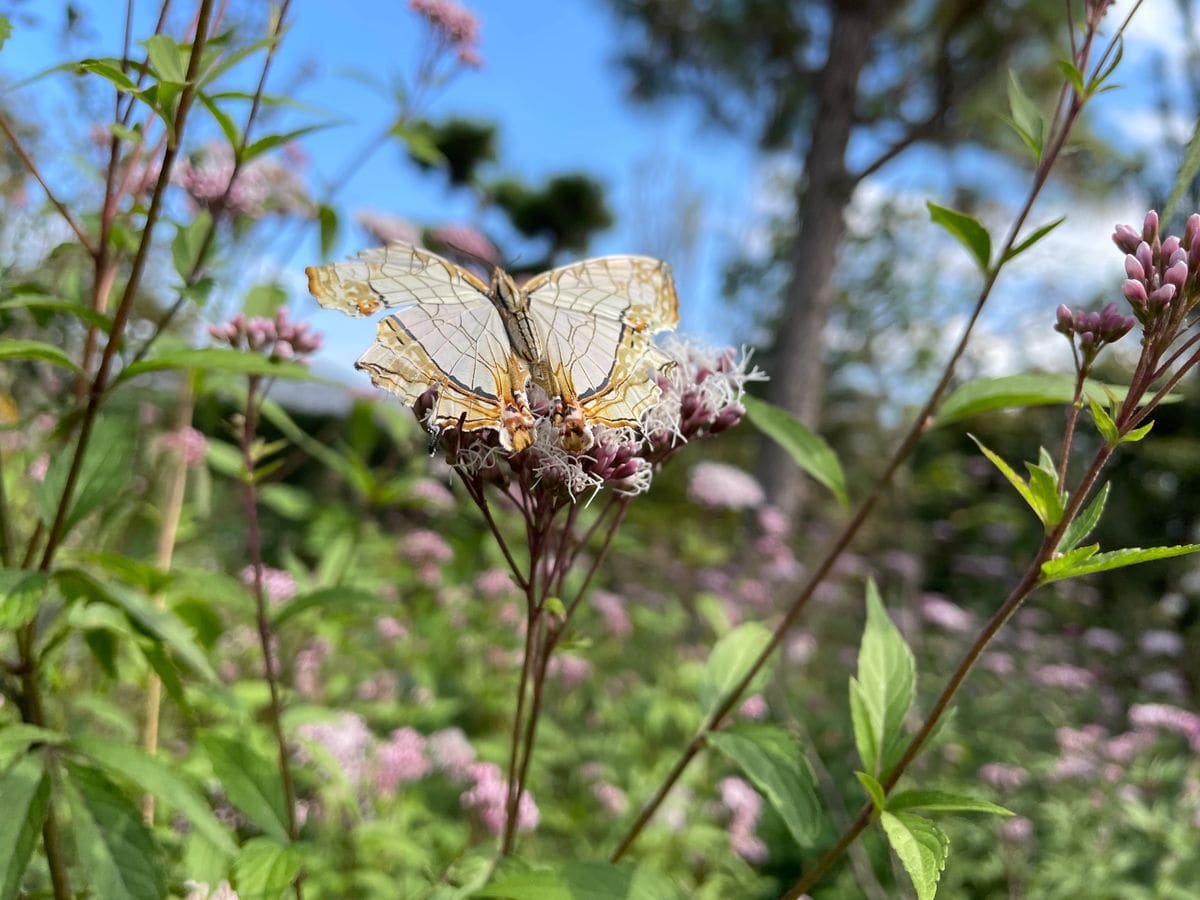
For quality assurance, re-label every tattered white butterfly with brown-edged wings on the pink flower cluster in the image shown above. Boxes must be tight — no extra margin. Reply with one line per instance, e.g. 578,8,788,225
305,241,679,452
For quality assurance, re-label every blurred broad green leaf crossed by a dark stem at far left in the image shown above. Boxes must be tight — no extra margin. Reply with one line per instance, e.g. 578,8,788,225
34,416,138,535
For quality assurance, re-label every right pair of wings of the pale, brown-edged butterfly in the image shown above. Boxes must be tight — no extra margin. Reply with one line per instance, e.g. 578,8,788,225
524,256,679,427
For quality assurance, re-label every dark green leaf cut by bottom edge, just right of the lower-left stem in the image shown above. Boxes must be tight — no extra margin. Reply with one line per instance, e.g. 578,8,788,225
66,762,167,900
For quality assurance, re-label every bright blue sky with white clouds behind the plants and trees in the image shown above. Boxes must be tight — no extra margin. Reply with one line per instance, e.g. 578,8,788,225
0,0,1186,384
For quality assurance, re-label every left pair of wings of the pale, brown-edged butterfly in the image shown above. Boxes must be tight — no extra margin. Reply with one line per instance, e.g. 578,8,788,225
306,242,532,444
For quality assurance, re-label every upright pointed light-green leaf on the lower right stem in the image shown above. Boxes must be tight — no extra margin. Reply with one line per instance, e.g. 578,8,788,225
858,580,917,775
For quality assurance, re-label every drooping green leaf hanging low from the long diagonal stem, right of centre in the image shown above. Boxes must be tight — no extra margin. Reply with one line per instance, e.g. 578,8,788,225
707,725,823,847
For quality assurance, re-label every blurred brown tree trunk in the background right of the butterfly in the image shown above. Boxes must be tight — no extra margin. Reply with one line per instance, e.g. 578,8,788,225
760,0,887,521
